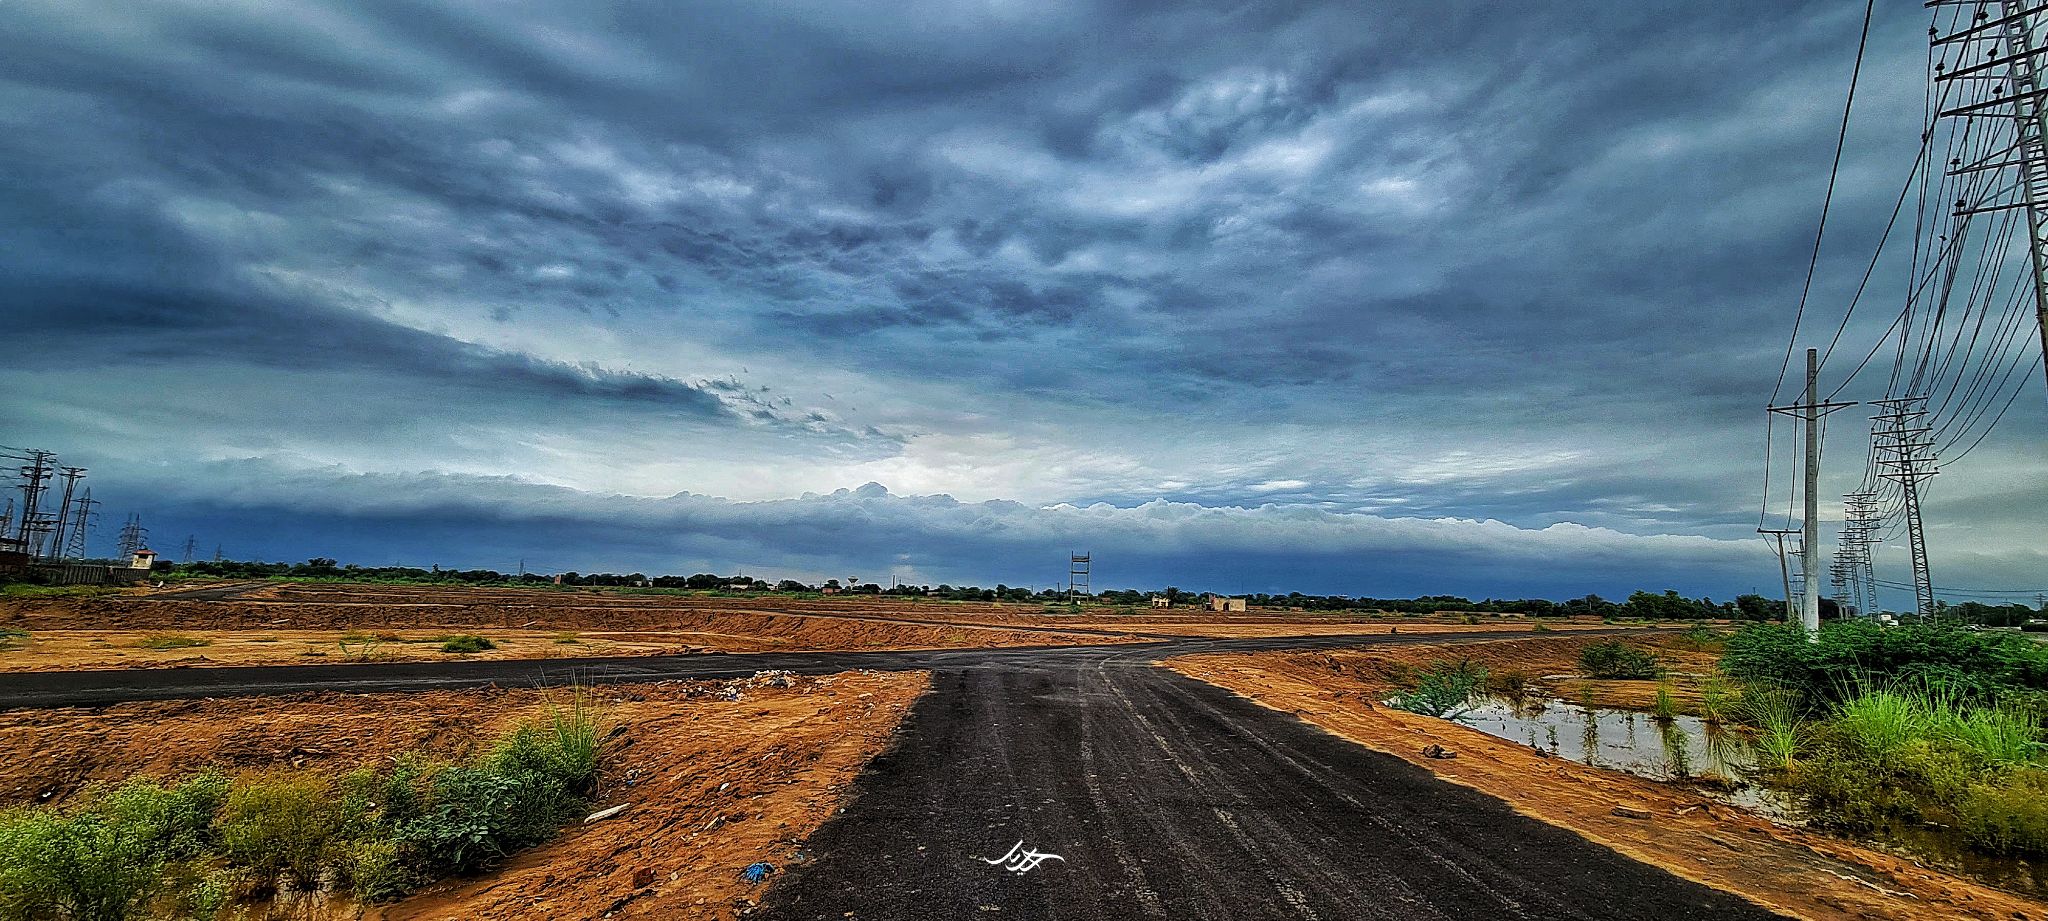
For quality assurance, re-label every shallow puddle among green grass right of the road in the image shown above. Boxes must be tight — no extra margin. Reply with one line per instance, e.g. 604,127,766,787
1460,696,2048,898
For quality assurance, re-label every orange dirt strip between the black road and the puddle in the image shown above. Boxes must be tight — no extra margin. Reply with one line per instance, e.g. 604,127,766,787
1165,637,2048,921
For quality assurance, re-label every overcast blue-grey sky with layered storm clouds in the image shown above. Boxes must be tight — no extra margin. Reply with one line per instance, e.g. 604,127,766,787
0,0,2048,606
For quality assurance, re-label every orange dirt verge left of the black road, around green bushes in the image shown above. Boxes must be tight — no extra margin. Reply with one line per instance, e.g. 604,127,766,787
0,671,928,921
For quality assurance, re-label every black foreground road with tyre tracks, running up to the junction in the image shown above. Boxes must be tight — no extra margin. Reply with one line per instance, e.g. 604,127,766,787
762,637,1776,921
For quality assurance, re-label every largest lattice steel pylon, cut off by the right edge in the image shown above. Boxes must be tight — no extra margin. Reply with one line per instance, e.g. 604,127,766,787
1927,0,2048,395
